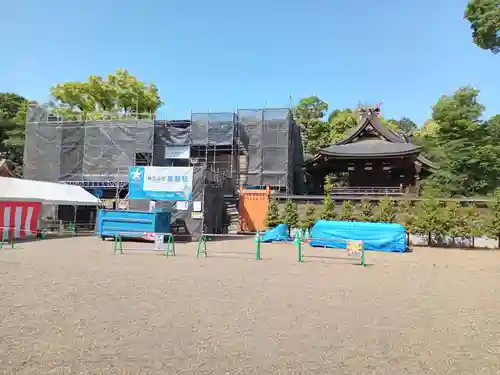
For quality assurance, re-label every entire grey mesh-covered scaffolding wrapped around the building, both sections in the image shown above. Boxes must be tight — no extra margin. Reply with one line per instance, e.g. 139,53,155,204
24,106,303,200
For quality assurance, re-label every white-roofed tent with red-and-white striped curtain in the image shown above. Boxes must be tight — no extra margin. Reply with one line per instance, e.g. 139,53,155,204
0,177,100,240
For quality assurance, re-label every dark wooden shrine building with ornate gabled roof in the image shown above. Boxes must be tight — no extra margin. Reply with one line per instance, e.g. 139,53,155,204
303,105,437,195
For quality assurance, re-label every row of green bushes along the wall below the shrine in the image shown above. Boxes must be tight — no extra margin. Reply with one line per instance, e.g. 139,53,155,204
265,190,500,247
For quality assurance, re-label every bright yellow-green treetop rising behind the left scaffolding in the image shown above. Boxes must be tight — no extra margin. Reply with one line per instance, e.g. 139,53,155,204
51,69,163,114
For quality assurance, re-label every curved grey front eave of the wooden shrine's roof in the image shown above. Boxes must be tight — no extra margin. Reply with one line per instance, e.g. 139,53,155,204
319,139,421,157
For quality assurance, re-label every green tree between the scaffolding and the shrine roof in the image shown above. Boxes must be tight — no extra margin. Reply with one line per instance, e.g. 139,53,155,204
295,96,329,155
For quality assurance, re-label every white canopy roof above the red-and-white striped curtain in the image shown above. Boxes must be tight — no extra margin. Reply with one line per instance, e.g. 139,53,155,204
0,177,100,206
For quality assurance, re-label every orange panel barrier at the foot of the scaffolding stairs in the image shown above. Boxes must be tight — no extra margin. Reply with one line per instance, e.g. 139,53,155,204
240,186,271,232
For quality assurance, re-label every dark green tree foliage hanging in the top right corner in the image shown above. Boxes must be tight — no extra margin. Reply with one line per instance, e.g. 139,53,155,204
465,0,500,54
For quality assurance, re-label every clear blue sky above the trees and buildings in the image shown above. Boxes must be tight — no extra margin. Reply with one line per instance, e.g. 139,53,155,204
0,0,500,123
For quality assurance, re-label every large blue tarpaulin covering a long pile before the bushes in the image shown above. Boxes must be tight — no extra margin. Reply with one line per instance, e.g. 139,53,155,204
309,220,407,252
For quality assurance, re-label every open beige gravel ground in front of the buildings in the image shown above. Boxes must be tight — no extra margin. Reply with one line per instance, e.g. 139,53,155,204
0,238,500,375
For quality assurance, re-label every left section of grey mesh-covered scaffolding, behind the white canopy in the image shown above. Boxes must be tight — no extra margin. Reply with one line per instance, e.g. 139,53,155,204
24,106,154,200
